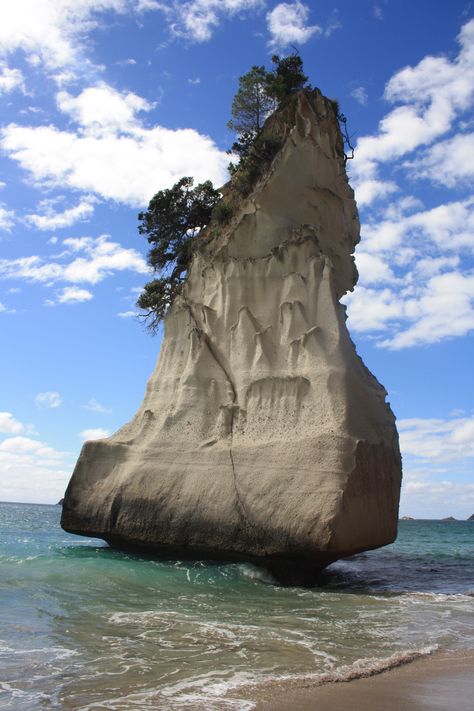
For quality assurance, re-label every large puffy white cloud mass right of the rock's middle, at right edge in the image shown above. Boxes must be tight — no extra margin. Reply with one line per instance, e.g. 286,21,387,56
345,197,474,350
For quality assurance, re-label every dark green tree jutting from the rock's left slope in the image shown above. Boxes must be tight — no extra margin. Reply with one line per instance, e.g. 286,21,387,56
137,177,221,333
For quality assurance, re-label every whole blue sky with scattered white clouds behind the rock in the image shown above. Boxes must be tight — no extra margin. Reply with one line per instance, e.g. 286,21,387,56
0,0,474,518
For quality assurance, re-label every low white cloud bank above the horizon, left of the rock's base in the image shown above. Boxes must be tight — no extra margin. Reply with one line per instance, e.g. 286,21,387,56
0,436,73,503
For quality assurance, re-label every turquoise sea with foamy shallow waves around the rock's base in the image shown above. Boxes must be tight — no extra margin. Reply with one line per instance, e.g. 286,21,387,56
0,504,474,711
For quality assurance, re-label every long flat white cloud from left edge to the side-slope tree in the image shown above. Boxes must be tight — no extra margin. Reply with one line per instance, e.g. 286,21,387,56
0,235,149,284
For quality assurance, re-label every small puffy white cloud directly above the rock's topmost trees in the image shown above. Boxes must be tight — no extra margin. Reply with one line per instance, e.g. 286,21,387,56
267,0,322,48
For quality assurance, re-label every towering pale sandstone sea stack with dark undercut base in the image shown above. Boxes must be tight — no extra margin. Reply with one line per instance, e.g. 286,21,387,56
61,90,401,579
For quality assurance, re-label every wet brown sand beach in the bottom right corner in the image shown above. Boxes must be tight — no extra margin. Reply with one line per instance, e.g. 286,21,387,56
255,650,474,711
